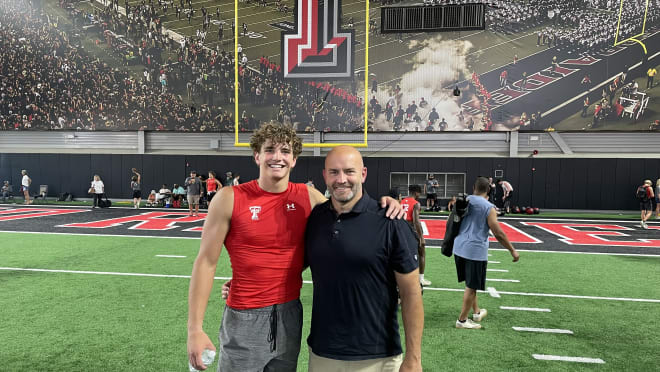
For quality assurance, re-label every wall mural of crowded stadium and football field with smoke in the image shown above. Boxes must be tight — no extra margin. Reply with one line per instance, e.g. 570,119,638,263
0,0,660,132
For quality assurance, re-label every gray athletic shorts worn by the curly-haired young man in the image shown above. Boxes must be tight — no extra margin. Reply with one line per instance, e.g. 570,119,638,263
218,300,302,372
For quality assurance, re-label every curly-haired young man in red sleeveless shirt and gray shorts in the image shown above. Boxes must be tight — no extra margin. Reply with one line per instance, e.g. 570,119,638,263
188,124,400,372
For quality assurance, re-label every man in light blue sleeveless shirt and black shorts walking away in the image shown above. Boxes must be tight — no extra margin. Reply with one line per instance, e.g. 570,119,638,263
454,177,520,329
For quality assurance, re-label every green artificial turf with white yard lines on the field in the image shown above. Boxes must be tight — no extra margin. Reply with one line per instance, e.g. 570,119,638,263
0,233,660,371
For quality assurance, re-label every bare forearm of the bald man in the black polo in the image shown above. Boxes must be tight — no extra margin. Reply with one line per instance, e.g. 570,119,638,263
394,269,424,371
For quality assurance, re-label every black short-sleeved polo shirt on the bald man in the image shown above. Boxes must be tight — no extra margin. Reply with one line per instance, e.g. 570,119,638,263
305,193,418,360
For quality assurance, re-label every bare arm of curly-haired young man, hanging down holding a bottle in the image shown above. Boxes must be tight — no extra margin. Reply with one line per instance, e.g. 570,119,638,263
188,187,234,369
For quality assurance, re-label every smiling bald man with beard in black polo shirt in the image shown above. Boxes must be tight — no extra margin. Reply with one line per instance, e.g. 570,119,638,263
305,146,424,372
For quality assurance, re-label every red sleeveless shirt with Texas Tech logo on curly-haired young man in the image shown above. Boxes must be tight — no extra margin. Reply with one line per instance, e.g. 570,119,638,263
225,180,312,309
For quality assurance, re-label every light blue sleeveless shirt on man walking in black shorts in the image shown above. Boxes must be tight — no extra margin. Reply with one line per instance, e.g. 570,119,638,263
454,195,495,261
